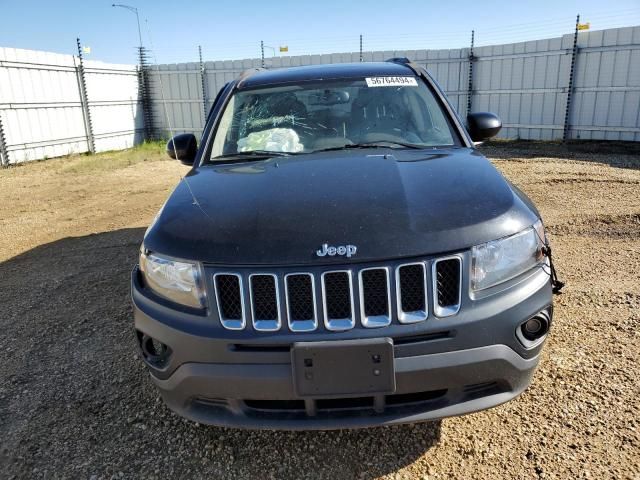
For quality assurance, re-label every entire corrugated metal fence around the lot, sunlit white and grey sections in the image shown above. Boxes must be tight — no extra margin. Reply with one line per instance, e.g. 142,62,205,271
0,27,640,162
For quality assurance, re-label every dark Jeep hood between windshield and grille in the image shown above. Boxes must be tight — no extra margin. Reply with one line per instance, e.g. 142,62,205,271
144,148,537,265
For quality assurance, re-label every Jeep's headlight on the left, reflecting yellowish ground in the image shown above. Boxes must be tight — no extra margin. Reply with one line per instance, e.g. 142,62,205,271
140,251,205,308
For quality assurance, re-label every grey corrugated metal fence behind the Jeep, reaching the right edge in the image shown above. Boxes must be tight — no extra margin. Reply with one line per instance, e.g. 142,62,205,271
152,27,640,141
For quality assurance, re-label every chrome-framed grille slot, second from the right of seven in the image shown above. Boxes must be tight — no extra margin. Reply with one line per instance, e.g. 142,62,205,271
396,263,428,323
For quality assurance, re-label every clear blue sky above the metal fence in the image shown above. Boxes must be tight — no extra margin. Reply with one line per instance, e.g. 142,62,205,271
0,0,640,63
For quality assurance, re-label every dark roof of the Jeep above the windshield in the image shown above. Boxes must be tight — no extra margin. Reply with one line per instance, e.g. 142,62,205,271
238,62,415,90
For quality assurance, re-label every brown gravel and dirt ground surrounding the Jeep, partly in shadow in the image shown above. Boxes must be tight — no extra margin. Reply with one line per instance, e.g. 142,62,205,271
0,144,640,480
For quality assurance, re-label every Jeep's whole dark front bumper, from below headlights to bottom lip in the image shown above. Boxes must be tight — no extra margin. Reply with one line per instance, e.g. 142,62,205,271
132,271,551,430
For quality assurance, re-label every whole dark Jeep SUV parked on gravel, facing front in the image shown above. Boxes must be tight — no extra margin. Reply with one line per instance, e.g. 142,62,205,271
127,59,555,429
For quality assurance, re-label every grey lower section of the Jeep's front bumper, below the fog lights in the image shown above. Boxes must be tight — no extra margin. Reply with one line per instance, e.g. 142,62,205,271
152,345,538,430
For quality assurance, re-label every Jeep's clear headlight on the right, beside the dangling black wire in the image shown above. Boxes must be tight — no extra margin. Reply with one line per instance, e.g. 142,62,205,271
471,221,545,290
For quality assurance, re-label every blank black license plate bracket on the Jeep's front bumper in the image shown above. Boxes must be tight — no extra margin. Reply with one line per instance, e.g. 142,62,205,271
291,338,396,397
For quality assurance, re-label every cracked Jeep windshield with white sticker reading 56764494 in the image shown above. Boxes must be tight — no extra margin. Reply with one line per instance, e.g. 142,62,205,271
211,76,458,161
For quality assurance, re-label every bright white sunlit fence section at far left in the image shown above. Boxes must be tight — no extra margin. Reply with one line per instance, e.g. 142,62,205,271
0,48,143,163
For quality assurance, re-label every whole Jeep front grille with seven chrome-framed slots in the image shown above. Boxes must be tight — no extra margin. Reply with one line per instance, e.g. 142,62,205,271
208,256,462,332
